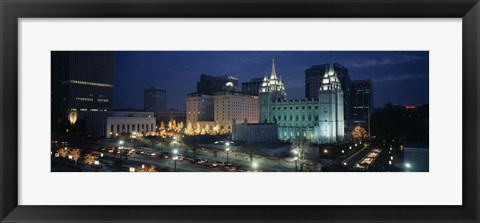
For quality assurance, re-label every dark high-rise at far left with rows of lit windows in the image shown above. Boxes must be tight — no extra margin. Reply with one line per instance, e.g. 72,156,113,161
51,51,114,130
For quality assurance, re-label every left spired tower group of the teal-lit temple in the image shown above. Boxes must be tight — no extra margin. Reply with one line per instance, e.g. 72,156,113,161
258,59,287,123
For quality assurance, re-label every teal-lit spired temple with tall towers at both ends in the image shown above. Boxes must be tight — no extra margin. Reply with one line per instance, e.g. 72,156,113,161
259,58,345,143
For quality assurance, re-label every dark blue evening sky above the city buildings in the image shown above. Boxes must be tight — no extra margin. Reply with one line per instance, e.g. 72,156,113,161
114,51,429,110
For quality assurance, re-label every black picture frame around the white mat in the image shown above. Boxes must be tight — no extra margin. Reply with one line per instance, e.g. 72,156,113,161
0,0,480,223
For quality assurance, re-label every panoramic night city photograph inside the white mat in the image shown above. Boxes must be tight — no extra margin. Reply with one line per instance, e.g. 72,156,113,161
50,51,429,173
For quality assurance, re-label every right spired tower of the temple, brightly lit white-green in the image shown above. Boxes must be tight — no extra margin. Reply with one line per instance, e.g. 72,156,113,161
317,59,345,143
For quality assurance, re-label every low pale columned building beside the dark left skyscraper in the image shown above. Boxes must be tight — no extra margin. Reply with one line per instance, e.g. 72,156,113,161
87,111,156,138
